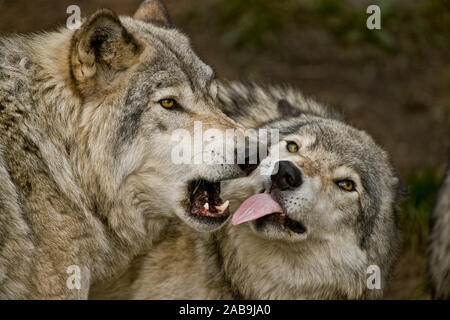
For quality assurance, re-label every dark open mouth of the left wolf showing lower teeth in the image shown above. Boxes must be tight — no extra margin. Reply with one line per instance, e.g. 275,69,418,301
188,179,230,220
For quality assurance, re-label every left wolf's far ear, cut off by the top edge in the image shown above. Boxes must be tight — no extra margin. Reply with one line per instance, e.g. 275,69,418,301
133,0,173,28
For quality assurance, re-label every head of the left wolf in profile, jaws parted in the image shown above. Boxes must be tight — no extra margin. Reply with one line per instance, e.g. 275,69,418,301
69,1,250,230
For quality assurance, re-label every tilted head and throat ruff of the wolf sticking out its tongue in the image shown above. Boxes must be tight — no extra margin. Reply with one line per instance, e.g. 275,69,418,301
223,100,399,298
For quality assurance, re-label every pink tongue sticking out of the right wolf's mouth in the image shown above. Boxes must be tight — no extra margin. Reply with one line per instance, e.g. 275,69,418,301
231,193,283,226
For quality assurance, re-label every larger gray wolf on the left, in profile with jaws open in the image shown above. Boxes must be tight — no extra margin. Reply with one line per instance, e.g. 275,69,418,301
0,1,248,299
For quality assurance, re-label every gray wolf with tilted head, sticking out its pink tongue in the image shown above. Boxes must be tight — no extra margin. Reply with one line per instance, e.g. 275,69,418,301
89,83,402,299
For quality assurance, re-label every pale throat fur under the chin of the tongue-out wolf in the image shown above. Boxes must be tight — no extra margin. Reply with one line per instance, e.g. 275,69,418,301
210,226,365,299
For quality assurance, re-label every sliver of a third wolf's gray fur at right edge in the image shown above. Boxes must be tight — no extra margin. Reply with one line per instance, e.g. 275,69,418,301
428,167,450,300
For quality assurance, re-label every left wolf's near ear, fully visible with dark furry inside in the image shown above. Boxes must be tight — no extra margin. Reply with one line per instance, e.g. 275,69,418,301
70,9,142,84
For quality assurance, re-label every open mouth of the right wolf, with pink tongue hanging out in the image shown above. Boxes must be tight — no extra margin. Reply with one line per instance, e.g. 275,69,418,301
232,187,306,234
